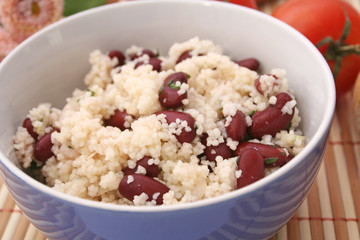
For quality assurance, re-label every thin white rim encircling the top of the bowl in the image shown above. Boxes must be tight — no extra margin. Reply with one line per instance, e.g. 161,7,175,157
0,0,336,213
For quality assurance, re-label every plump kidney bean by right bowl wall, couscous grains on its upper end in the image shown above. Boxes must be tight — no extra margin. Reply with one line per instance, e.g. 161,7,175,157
249,93,295,139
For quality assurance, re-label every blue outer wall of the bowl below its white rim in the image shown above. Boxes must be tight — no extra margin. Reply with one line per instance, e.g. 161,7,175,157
1,131,327,240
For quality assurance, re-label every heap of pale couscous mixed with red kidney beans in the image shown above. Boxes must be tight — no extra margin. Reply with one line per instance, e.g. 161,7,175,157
14,37,305,205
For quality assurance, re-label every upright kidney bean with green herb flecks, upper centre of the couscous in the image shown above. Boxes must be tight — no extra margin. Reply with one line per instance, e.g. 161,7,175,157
159,72,188,109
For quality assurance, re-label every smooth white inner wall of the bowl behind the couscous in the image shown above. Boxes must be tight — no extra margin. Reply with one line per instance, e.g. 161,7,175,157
0,0,335,207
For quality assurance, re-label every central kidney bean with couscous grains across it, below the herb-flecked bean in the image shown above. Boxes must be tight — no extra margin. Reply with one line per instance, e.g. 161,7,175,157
155,110,196,143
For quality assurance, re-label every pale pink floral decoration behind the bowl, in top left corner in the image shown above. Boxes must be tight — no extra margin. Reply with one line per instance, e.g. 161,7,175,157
0,0,64,61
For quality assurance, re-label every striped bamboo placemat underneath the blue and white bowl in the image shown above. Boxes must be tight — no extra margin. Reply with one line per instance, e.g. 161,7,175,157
0,0,360,240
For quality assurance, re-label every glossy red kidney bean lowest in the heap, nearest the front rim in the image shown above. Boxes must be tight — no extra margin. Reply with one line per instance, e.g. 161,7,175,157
118,174,170,205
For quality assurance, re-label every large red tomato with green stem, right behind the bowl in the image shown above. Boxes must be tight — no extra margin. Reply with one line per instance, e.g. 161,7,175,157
272,0,360,97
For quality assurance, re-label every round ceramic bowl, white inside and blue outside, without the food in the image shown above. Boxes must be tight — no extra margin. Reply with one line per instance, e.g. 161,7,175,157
0,0,335,239
